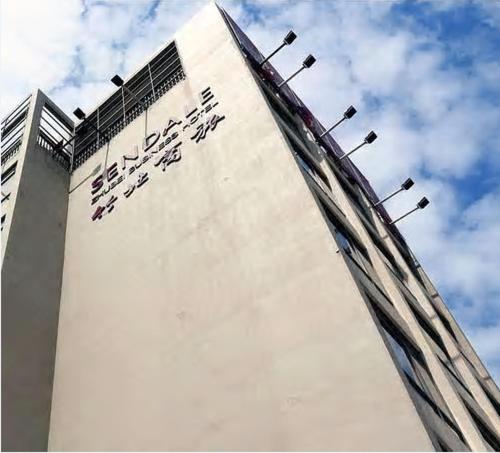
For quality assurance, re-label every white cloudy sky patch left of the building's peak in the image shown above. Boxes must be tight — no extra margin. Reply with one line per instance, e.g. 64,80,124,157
0,0,206,117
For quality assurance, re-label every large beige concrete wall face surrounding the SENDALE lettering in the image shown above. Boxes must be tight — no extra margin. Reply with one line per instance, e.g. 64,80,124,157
49,5,432,450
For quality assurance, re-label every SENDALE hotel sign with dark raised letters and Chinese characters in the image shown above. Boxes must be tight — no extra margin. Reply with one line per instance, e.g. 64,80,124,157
90,87,225,221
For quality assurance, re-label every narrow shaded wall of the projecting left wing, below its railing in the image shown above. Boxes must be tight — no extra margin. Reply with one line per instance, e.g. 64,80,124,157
2,92,69,451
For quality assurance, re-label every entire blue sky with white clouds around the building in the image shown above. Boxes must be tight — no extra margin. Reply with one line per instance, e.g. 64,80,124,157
0,0,500,383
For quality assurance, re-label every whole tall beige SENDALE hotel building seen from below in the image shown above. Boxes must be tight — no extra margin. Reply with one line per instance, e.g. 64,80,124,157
2,4,500,451
